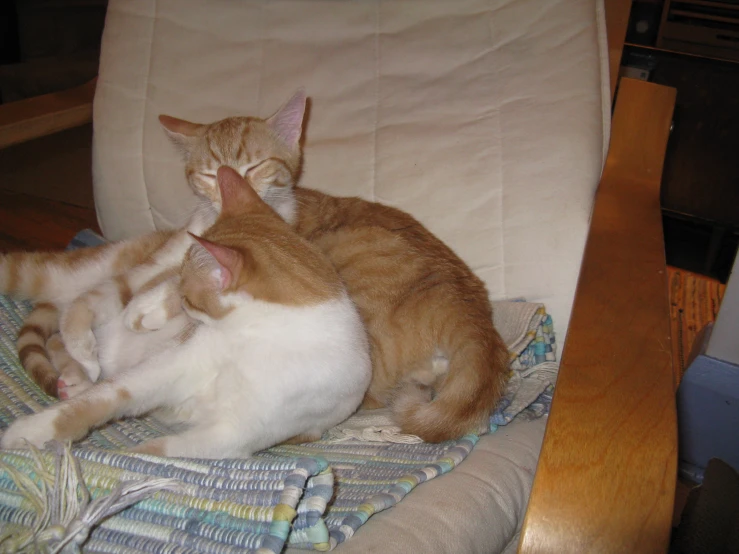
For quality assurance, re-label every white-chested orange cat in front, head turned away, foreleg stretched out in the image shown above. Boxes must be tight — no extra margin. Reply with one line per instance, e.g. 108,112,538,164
2,168,371,458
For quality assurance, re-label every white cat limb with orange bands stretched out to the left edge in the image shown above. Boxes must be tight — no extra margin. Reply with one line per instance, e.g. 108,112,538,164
0,232,171,304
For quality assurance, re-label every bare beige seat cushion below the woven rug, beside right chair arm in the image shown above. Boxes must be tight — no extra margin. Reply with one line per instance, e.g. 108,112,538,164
286,418,546,554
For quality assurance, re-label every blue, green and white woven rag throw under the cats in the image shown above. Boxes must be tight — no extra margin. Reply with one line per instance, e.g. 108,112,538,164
0,296,478,554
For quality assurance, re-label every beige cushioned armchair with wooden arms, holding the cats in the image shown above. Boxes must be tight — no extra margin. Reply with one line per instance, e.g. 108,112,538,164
0,0,676,553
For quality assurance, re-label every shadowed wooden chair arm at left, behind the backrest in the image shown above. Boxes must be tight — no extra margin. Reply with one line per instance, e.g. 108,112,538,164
0,77,97,148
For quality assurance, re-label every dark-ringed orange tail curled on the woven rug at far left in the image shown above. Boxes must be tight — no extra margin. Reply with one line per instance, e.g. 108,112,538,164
18,302,59,396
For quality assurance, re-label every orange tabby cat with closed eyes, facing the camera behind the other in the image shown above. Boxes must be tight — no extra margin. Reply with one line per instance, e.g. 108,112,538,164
160,90,508,442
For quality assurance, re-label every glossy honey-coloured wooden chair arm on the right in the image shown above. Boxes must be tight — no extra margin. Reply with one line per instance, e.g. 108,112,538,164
518,79,677,553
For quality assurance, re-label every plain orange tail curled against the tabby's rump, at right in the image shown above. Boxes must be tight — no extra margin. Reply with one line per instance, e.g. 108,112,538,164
391,323,509,442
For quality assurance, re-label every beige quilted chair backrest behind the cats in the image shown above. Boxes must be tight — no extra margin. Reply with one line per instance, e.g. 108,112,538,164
94,0,610,340
